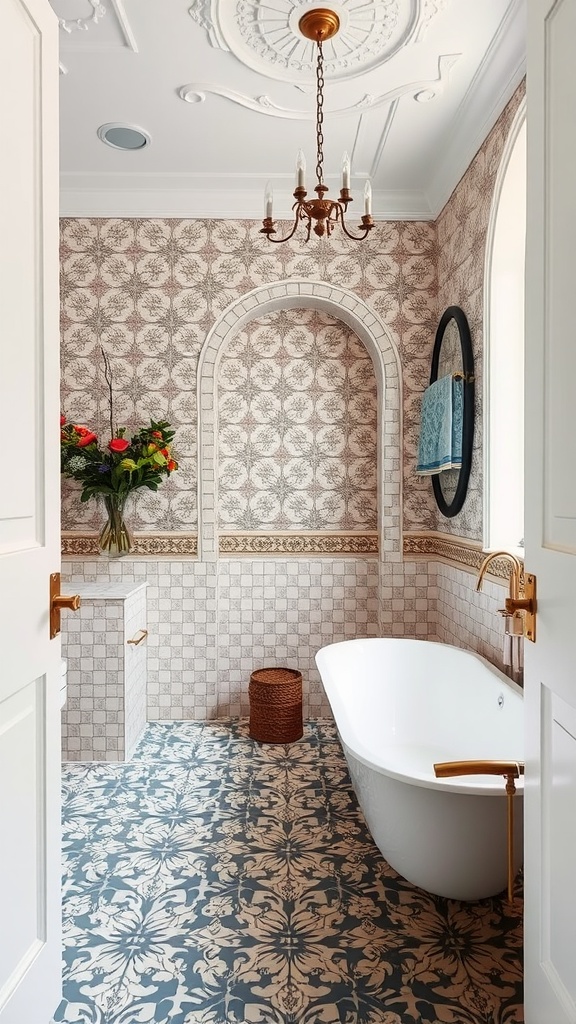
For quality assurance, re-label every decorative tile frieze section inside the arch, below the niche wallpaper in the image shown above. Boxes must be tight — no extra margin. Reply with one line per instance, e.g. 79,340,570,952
218,532,378,555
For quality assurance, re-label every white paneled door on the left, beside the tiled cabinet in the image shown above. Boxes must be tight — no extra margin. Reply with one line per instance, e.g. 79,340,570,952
0,0,60,1024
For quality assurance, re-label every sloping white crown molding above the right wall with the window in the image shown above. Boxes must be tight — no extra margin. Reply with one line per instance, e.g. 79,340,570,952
426,0,526,219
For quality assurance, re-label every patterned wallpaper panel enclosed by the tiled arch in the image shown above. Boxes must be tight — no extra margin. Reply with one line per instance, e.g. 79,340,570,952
218,309,377,531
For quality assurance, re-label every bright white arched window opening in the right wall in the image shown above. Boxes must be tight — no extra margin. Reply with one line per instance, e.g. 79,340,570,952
484,116,526,555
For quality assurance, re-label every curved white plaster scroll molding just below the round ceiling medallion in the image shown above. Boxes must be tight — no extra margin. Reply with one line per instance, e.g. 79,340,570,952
178,53,461,121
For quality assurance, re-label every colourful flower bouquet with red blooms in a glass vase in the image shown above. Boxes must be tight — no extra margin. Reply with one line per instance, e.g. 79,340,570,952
60,352,178,556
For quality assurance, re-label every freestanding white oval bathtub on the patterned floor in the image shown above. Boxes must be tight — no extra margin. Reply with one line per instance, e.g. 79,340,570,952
316,638,523,900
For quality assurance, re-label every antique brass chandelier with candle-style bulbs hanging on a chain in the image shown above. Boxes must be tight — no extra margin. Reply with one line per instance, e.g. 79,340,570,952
260,7,374,242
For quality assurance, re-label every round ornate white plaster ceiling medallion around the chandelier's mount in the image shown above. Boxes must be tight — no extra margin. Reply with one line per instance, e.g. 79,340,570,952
189,0,448,83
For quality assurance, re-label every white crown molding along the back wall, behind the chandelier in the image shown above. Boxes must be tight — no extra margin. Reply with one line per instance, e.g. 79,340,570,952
60,173,433,221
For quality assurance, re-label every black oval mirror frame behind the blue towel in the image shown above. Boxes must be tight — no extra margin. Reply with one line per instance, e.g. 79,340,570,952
430,306,475,519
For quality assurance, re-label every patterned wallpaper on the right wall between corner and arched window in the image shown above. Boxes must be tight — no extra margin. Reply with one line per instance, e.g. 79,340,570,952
436,84,525,541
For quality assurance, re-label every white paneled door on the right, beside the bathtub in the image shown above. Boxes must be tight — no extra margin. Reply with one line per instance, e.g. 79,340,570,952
525,0,576,1024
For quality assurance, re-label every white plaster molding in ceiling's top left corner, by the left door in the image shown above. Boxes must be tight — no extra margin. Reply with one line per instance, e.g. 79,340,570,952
50,0,138,53
